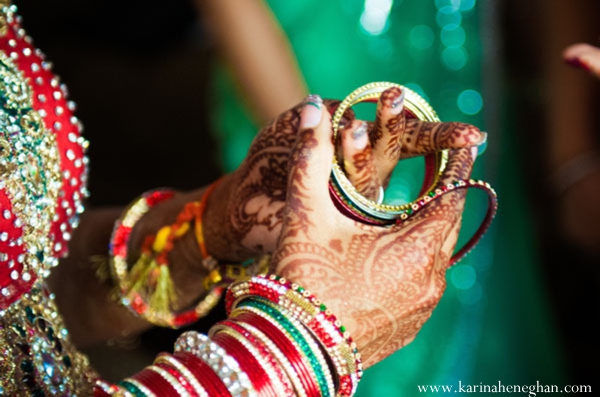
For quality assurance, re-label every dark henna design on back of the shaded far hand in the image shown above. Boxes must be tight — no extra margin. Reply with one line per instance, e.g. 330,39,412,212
205,100,355,260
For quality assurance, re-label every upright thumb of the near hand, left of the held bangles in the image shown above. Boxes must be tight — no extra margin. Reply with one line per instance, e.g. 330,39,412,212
286,95,333,231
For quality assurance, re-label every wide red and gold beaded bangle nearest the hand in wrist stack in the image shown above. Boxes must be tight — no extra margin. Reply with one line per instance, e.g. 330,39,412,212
225,275,363,396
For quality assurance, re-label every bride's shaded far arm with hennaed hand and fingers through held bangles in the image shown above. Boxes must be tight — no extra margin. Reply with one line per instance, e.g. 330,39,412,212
51,91,484,345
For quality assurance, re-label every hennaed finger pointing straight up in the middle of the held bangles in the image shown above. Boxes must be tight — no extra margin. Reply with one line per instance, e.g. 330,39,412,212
370,87,405,185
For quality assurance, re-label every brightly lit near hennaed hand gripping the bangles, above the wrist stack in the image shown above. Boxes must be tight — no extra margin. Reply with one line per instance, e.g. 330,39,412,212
271,100,477,367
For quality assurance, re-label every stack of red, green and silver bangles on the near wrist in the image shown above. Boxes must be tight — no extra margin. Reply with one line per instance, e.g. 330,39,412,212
95,275,362,397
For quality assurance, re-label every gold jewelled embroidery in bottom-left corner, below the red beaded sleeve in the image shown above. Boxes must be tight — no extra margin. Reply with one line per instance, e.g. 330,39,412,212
0,282,97,396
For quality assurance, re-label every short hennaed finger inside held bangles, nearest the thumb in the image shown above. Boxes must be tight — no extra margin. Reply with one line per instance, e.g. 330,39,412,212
342,120,381,200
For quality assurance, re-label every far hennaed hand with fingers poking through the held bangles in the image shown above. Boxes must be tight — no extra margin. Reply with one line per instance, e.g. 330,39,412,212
206,88,485,260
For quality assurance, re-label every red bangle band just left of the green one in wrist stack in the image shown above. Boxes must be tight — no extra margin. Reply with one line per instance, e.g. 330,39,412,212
234,311,320,396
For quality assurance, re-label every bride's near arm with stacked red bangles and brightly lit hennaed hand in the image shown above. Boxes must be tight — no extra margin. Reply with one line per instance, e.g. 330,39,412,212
97,94,486,396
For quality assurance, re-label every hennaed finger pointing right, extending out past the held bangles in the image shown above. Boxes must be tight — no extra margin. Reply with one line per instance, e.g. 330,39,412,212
402,119,487,158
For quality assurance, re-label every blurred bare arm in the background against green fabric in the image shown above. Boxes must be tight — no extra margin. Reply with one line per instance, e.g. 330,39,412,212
196,0,307,125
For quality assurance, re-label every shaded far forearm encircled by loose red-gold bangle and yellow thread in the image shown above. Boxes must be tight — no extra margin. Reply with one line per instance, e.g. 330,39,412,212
49,177,248,346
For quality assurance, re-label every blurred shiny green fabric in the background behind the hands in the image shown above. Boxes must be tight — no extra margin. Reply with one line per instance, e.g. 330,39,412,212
214,0,564,397
